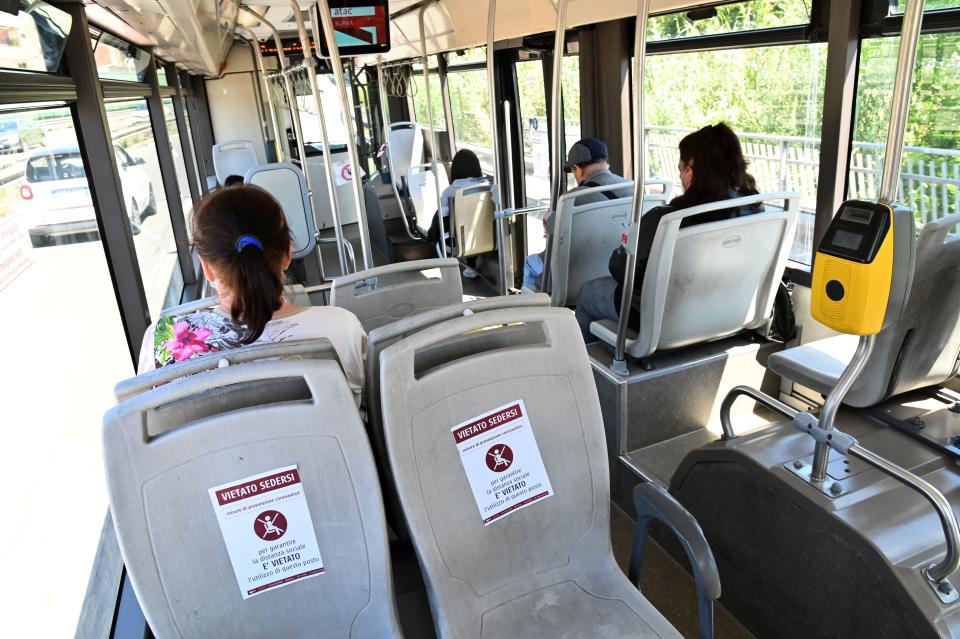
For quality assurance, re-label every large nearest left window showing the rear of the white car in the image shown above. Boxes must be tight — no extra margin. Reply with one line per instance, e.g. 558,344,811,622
0,102,133,637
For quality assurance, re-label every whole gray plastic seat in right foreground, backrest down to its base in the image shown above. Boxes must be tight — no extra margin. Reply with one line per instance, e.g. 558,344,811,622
380,308,680,639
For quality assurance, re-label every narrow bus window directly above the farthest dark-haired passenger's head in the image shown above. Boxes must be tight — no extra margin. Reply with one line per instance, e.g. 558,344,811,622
447,67,493,171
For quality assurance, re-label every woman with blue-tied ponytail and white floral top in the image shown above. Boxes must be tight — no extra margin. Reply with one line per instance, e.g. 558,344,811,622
139,186,367,400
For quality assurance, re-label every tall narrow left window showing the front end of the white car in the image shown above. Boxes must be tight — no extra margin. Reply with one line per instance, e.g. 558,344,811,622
106,100,182,318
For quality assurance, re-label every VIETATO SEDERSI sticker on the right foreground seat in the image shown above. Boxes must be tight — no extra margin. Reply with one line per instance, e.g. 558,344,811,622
451,399,553,526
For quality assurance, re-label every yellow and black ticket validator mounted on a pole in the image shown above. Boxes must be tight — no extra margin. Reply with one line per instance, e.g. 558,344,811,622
810,200,894,335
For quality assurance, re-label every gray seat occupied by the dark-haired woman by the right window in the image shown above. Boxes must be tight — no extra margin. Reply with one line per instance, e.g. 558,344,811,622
590,193,800,358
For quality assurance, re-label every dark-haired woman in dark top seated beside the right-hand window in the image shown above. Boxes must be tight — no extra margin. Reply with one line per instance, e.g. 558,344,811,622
576,122,763,343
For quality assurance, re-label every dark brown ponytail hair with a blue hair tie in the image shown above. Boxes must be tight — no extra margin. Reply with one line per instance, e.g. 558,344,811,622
193,185,290,344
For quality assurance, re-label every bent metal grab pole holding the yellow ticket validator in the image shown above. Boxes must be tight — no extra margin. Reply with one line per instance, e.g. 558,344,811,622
810,0,923,481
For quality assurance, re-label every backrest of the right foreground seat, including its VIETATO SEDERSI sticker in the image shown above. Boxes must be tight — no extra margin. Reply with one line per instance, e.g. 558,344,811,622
380,308,616,637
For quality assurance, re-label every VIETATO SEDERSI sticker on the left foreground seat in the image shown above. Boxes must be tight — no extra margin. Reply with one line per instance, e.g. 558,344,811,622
210,466,325,599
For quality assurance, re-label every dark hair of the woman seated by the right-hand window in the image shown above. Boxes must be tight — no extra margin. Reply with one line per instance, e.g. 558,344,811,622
670,122,757,208
